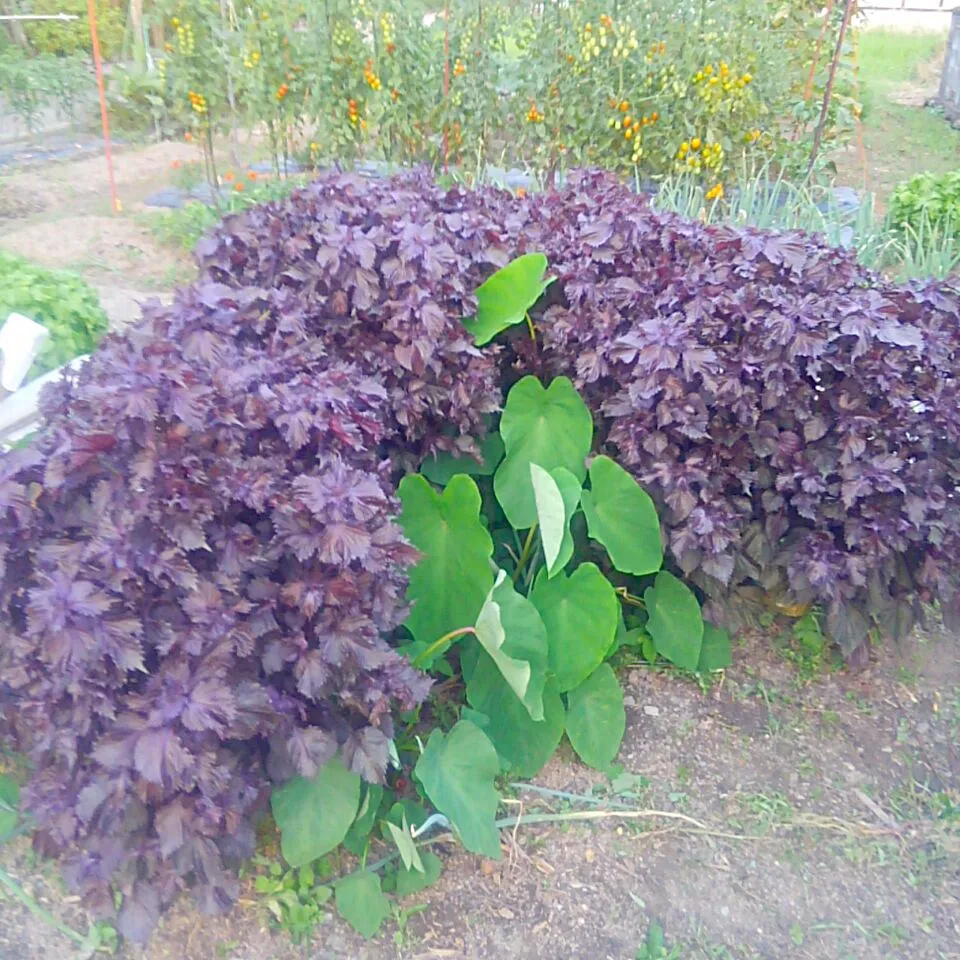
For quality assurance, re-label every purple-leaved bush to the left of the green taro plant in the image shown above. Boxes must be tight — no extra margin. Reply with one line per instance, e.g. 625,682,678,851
0,171,500,939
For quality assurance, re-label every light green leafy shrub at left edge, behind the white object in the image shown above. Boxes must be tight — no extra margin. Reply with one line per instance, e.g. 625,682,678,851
0,253,107,375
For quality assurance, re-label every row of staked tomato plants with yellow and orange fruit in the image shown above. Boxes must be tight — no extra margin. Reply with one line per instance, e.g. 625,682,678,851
152,0,857,191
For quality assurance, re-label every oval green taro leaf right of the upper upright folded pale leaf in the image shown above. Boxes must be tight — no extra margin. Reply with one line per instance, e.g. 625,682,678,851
582,457,663,577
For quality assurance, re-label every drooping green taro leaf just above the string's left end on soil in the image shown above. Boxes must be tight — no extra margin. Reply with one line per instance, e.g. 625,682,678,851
414,720,500,860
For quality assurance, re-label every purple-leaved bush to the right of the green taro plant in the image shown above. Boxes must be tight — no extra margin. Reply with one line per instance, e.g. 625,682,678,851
521,175,960,656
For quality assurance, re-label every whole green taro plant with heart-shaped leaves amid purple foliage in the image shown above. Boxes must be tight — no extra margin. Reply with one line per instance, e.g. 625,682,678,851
258,253,730,936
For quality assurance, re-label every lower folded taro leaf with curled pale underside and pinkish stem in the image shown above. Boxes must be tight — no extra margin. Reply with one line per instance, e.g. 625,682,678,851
468,570,548,720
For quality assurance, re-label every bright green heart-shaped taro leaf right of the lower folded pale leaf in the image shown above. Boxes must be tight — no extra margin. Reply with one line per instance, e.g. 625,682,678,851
530,563,620,693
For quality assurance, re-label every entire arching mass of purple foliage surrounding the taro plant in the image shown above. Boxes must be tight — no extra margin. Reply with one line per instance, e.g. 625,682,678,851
0,169,960,939
